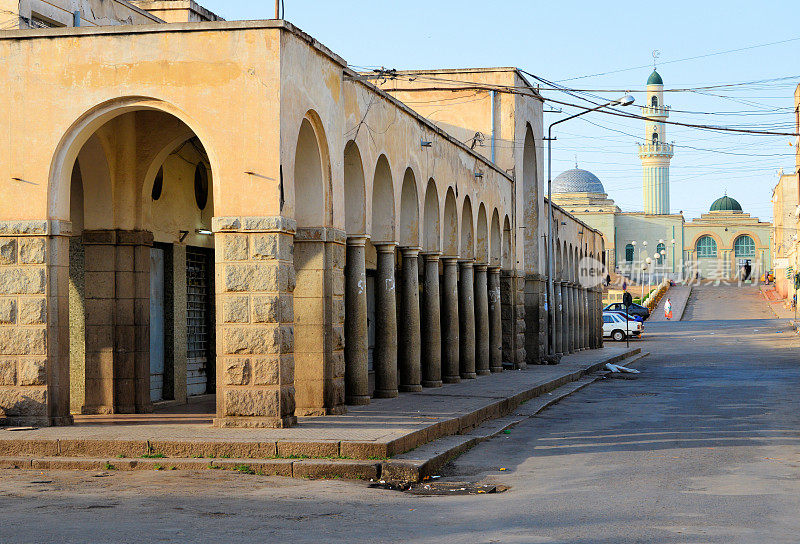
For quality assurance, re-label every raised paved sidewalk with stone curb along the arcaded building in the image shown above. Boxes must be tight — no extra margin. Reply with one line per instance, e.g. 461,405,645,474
0,344,641,478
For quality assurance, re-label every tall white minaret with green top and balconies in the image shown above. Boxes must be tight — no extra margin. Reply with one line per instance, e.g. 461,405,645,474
639,69,673,214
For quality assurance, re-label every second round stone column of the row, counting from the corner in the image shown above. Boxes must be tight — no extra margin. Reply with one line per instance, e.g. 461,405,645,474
372,242,398,399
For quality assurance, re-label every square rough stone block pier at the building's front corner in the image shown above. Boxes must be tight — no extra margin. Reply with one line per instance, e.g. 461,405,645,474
213,216,297,427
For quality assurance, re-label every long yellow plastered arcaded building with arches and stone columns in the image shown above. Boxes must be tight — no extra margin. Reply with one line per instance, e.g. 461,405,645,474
0,6,604,427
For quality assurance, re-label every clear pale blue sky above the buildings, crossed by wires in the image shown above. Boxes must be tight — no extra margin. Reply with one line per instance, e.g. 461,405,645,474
201,0,800,221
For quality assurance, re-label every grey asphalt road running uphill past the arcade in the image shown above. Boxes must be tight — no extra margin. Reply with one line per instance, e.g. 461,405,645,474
0,286,800,544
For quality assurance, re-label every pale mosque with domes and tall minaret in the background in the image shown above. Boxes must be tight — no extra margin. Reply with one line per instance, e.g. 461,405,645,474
552,70,772,280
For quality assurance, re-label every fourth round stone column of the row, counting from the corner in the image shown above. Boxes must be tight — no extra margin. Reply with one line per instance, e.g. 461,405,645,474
421,253,442,387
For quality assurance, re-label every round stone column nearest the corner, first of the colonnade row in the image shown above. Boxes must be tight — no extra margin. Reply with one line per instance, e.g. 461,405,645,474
344,236,370,405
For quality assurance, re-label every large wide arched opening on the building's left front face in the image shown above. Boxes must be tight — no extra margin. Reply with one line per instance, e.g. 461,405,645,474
64,106,216,422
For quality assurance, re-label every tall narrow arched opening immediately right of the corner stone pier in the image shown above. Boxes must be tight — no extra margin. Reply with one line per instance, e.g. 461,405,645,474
293,112,332,416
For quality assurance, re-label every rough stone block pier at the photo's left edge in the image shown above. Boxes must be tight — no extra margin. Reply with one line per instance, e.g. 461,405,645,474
0,221,71,425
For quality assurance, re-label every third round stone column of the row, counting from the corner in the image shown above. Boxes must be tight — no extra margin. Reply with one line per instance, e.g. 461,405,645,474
397,247,422,392
